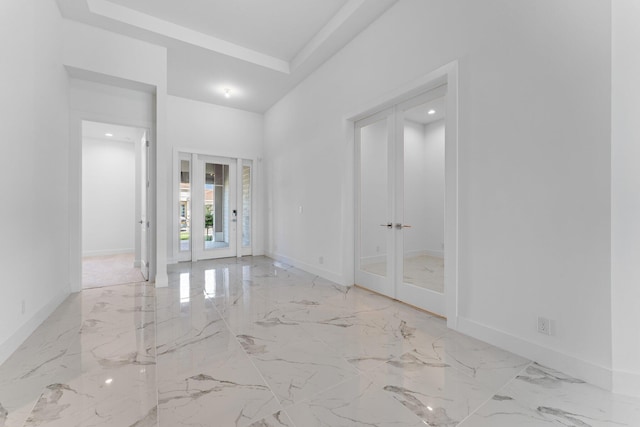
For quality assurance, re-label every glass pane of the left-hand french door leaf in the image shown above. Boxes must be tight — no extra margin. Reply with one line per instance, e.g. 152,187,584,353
359,118,389,277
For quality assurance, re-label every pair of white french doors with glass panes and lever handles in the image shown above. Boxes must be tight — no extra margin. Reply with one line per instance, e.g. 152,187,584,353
355,85,448,316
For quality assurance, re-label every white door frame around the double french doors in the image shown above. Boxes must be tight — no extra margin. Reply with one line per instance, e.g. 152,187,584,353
346,61,459,329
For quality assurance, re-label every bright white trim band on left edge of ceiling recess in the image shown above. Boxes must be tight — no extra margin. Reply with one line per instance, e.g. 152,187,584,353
87,0,290,74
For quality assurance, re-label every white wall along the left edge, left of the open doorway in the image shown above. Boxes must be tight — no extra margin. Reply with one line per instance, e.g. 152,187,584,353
0,0,69,363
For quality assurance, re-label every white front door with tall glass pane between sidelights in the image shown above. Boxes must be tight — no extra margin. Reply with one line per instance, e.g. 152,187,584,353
190,155,238,261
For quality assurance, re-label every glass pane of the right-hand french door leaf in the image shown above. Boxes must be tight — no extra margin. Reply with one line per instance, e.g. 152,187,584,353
402,99,444,293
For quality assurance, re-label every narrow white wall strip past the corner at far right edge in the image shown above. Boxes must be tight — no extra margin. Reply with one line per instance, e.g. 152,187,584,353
611,0,640,395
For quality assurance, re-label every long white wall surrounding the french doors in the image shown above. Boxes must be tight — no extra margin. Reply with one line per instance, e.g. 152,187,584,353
265,0,611,386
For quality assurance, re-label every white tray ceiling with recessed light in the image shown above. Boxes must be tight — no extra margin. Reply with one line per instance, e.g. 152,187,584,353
57,0,397,113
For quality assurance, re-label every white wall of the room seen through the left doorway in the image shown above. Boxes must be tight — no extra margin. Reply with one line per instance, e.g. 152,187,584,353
82,138,139,256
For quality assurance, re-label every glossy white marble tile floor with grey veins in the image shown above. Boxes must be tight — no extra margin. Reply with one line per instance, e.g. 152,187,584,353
0,257,640,427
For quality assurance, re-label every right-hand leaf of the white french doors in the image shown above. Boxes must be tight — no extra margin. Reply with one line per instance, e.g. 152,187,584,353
394,87,446,316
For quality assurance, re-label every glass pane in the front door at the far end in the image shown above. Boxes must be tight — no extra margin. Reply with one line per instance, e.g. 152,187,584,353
203,163,229,250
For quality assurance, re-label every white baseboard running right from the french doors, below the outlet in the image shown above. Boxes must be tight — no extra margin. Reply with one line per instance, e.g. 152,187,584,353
457,317,613,390
